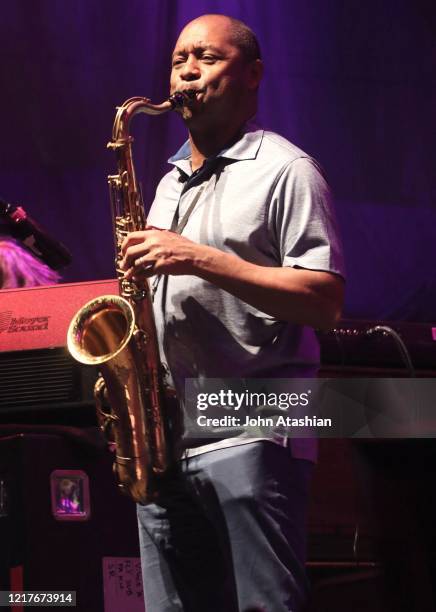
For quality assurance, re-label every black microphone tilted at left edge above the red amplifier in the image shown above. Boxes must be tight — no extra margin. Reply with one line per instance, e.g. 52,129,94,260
0,198,72,270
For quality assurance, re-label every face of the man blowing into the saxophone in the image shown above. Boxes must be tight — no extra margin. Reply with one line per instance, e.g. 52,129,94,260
170,16,257,125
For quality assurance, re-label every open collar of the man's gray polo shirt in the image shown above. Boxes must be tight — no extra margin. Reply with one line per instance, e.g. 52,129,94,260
168,122,264,176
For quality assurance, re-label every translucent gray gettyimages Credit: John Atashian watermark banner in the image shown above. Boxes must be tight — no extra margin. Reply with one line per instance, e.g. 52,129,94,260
183,378,436,438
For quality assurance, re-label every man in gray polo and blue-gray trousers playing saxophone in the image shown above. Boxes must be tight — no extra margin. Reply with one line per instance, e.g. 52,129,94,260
122,15,343,612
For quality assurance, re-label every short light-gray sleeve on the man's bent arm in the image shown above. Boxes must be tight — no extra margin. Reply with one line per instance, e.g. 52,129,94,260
268,157,345,278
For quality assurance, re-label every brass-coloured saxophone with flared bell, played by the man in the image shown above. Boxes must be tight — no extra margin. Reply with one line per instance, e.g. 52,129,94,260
67,91,195,503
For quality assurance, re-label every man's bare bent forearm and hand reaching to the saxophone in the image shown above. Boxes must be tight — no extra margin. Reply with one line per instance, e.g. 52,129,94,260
122,228,344,329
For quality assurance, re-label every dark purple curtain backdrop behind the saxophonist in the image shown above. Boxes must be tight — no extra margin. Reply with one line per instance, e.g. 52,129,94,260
0,0,436,321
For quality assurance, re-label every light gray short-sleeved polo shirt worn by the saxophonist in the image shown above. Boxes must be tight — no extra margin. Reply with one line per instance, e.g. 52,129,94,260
148,124,344,458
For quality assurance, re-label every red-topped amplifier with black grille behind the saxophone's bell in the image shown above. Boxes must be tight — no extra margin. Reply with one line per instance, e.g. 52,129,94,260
0,280,118,426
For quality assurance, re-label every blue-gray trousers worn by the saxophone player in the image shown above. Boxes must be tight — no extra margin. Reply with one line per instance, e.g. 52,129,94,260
138,441,312,612
